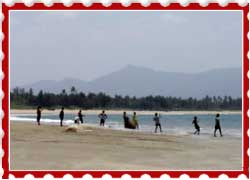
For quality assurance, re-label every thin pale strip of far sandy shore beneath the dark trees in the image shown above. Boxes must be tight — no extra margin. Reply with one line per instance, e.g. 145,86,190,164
10,109,242,115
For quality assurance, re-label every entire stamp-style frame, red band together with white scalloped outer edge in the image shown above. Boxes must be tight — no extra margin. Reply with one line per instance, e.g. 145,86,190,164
0,0,249,179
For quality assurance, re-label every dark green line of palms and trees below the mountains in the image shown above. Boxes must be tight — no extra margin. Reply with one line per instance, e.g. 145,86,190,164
10,87,242,111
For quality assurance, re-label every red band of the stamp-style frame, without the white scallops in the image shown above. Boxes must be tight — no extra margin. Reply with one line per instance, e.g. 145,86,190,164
2,3,249,179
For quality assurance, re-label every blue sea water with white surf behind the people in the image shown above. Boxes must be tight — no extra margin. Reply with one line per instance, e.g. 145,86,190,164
10,114,242,137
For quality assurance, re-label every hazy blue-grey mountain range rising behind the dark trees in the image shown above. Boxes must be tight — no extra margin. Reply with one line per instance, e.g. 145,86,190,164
19,65,242,98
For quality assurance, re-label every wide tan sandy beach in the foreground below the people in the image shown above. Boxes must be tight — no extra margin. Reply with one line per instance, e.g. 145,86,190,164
10,121,242,170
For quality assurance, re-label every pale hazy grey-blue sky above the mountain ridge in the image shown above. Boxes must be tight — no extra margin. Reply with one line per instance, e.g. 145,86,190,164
10,11,242,87
